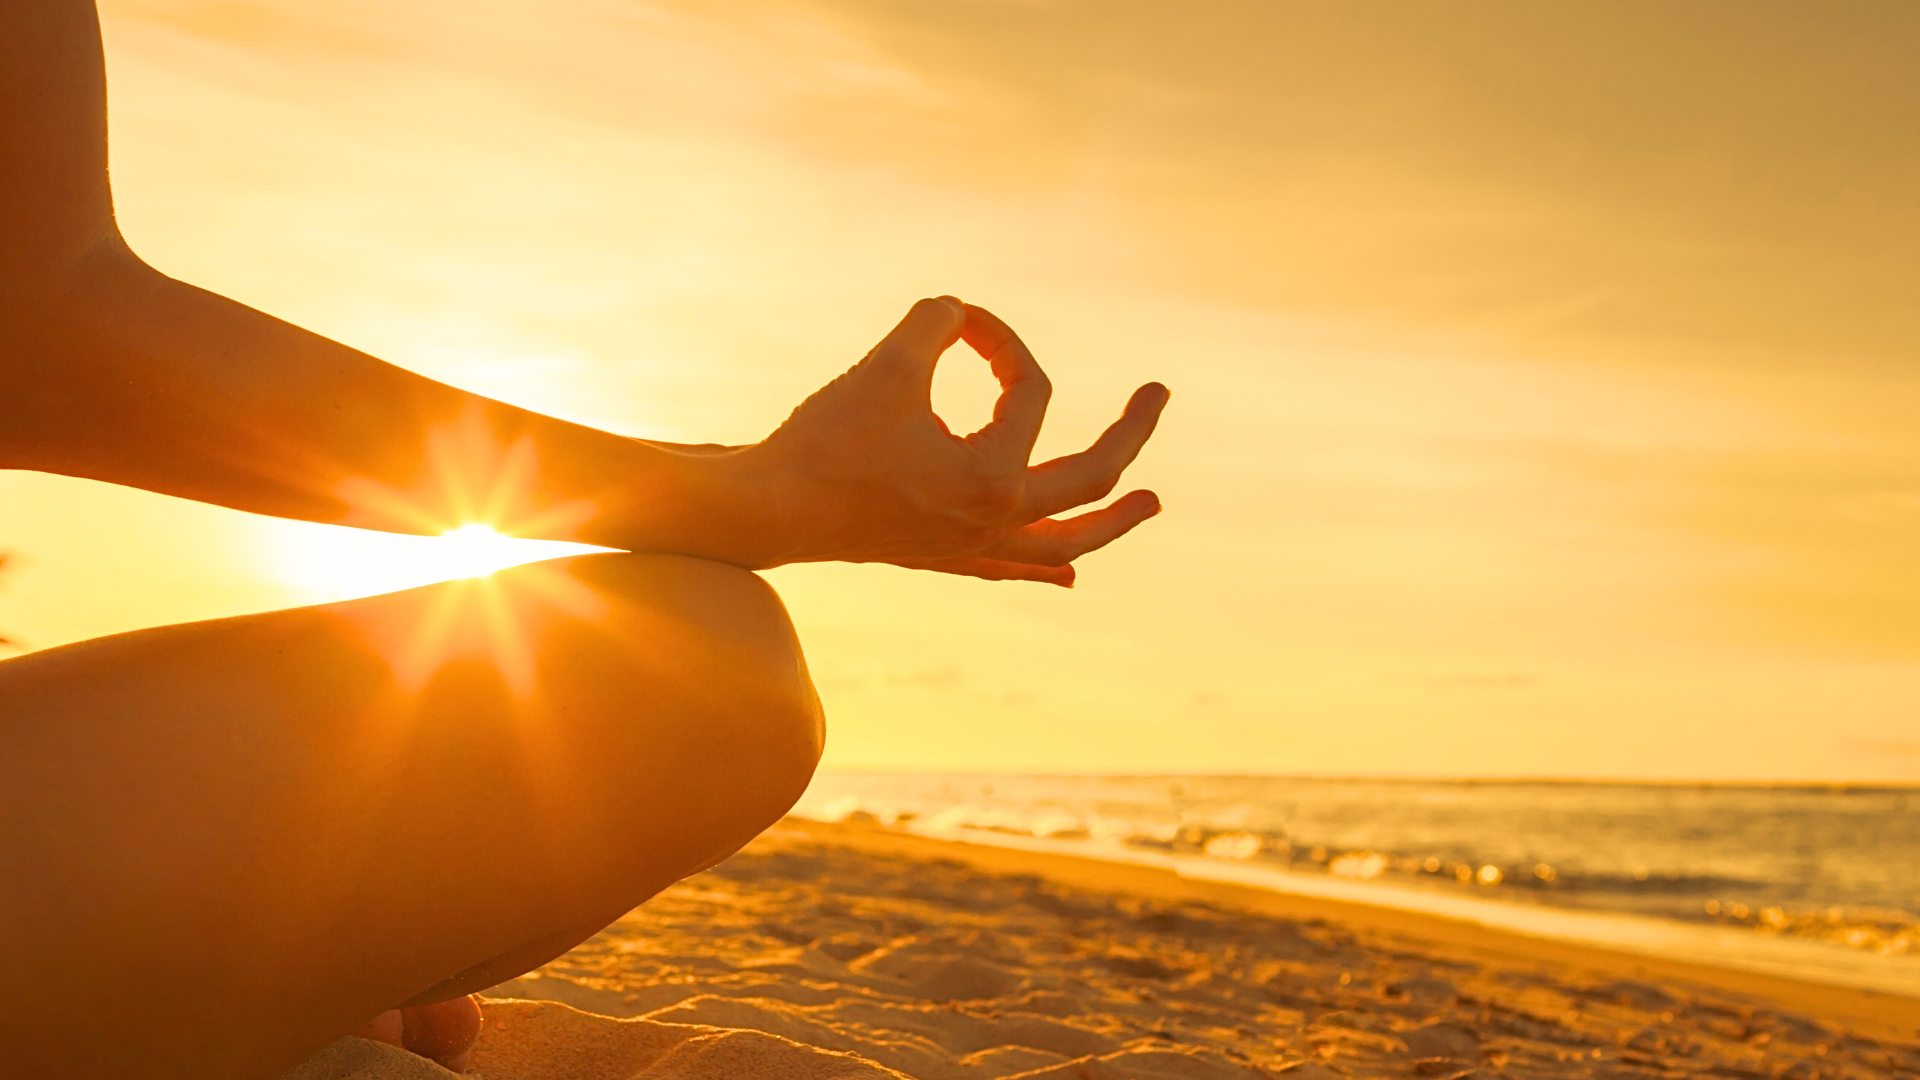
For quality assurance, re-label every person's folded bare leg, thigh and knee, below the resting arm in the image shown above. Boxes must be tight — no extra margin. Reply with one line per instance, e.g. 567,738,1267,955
0,555,822,1080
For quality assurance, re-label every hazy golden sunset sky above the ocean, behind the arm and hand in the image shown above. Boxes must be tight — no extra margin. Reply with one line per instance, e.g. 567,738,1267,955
0,0,1920,780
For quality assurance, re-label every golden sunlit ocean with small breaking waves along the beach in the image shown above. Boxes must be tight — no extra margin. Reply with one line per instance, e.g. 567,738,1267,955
795,773,1920,997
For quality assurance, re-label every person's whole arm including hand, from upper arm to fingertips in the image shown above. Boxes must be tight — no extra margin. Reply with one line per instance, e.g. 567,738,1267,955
0,0,1165,584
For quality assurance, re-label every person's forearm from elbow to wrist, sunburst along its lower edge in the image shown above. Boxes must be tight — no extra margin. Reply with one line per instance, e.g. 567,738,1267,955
0,242,771,561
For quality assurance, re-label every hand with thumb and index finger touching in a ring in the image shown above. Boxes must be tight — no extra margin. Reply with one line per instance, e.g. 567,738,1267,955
741,296,1167,586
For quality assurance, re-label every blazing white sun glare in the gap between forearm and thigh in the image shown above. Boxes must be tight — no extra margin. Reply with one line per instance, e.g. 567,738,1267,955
275,523,605,603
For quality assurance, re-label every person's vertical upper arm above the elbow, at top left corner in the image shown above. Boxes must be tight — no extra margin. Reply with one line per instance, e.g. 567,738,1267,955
0,0,117,277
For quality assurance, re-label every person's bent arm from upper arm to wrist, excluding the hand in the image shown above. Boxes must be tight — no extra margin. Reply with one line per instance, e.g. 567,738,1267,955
0,0,764,550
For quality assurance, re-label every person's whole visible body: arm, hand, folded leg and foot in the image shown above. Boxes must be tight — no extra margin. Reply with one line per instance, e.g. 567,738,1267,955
0,0,1167,1080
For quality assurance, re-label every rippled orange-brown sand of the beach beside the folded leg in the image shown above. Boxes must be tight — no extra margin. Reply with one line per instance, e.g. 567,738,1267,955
282,819,1920,1080
